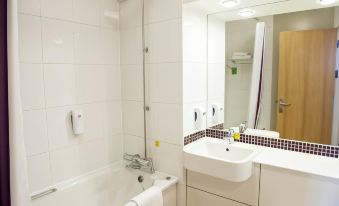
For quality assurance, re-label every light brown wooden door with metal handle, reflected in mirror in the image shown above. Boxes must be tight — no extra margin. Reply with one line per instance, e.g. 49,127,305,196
277,29,337,144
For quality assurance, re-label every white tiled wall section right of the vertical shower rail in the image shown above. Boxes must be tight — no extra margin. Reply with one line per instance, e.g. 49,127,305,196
145,0,185,205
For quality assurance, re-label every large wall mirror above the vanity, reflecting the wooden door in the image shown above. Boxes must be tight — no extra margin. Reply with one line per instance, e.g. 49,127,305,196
207,0,339,145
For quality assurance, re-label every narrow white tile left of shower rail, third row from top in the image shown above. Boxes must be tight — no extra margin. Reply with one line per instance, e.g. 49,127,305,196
121,65,144,101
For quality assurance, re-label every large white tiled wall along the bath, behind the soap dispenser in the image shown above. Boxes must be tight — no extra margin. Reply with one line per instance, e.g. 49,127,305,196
19,0,123,192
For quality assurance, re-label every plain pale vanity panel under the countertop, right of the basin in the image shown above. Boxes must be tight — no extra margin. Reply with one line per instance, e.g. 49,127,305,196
259,165,339,206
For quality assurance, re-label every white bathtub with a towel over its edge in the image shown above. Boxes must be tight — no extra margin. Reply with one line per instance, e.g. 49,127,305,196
32,164,178,206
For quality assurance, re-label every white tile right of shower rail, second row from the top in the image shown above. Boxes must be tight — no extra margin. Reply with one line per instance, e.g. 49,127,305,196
148,19,182,63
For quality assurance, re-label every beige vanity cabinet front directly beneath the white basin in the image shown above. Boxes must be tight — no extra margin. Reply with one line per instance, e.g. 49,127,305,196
187,164,260,206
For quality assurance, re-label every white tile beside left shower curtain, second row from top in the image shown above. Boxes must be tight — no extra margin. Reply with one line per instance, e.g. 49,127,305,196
19,14,42,63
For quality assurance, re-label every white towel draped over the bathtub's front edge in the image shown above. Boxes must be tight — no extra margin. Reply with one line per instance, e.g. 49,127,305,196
126,186,164,206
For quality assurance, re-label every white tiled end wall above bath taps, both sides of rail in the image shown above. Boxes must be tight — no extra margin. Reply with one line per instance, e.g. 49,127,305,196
120,0,185,204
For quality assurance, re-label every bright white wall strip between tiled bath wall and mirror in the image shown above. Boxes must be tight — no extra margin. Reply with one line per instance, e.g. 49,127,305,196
183,5,207,136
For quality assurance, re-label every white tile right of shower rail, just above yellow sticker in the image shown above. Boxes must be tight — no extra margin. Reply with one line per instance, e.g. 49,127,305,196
149,103,183,145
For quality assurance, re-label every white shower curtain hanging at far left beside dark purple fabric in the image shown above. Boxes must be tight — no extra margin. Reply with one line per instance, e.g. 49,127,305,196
7,0,30,206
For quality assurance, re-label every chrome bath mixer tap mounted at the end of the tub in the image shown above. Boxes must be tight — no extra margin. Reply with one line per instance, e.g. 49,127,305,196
124,153,155,174
